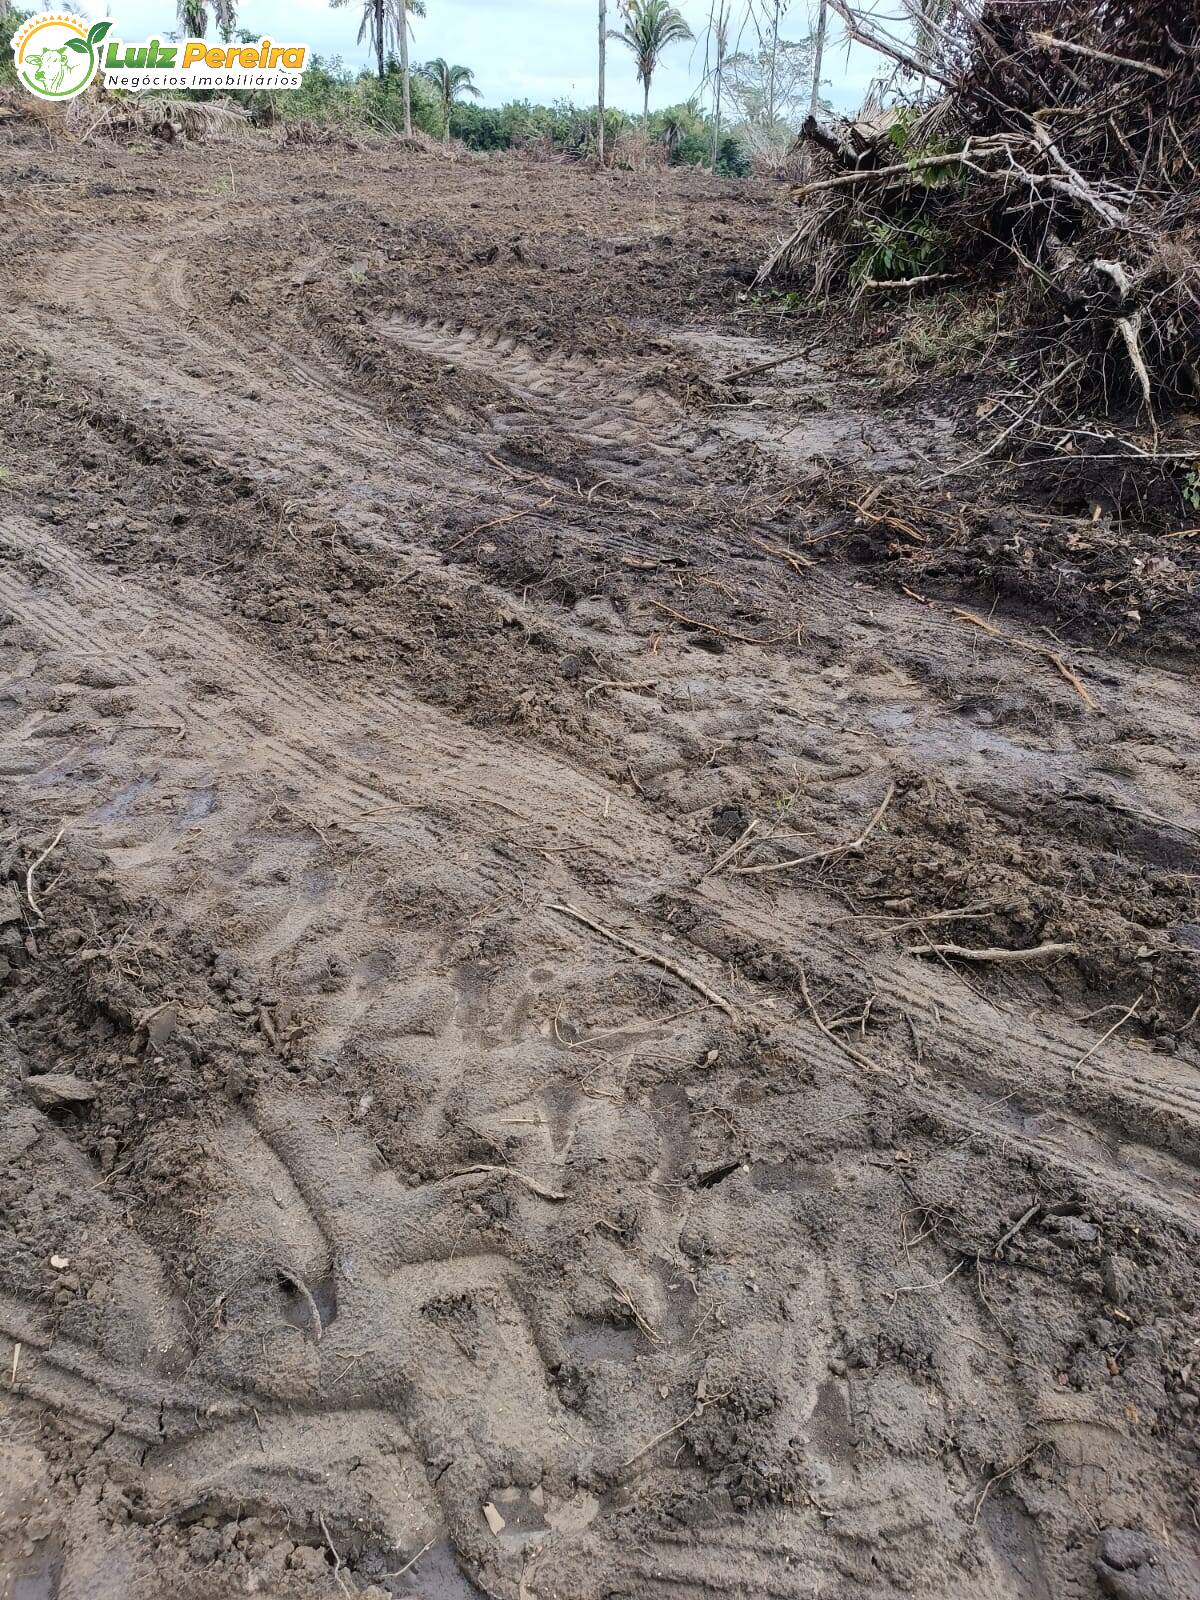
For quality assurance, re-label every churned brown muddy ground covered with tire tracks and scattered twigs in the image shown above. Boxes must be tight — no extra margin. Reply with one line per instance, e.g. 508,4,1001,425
0,130,1200,1600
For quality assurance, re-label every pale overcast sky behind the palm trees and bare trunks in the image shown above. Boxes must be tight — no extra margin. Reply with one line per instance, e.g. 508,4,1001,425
94,0,878,110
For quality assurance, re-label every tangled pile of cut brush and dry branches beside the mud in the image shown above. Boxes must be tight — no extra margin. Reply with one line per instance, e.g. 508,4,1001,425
758,0,1200,520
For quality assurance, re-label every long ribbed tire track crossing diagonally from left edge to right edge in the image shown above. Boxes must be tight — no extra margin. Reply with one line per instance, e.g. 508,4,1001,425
0,520,1200,1203
